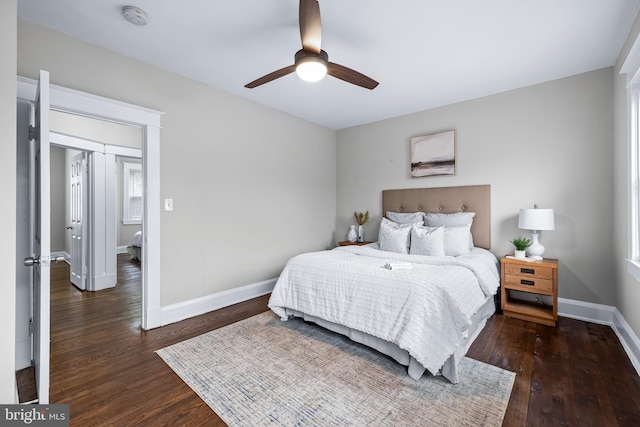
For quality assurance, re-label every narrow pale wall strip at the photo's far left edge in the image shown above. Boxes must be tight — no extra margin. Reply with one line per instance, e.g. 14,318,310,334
0,0,18,403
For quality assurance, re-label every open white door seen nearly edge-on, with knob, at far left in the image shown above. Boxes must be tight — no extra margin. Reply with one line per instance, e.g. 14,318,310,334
25,71,51,404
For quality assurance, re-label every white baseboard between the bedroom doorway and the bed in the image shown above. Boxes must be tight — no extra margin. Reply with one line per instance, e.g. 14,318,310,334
161,279,277,326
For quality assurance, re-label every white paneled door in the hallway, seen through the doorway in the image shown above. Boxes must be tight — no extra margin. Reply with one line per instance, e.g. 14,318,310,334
69,152,87,290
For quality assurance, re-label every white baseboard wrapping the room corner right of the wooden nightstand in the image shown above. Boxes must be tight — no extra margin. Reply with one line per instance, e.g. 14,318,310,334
558,298,640,374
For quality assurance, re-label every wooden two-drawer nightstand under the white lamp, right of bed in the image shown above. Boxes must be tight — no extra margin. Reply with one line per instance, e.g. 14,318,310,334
500,257,558,326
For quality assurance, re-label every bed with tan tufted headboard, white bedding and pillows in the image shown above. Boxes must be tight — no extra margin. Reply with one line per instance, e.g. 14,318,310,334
269,185,499,383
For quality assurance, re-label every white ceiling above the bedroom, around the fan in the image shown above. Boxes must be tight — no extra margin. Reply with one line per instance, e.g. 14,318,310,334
18,0,640,130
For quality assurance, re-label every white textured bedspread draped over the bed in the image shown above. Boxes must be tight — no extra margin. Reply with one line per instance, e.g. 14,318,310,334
269,244,499,375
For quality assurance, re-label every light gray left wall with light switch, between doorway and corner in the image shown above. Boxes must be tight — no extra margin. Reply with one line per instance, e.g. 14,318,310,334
14,19,336,306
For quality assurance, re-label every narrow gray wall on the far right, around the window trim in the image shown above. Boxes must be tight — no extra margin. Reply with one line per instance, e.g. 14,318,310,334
612,17,640,344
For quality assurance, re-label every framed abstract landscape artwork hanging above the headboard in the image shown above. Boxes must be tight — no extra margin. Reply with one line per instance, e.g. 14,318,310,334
411,130,456,178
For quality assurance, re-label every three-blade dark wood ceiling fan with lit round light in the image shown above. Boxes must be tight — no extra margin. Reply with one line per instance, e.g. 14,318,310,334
244,0,378,89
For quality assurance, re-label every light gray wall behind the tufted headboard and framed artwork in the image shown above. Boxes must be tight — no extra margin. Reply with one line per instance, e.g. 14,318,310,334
336,68,616,305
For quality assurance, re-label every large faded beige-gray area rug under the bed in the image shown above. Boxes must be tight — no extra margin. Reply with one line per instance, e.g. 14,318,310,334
157,312,515,427
